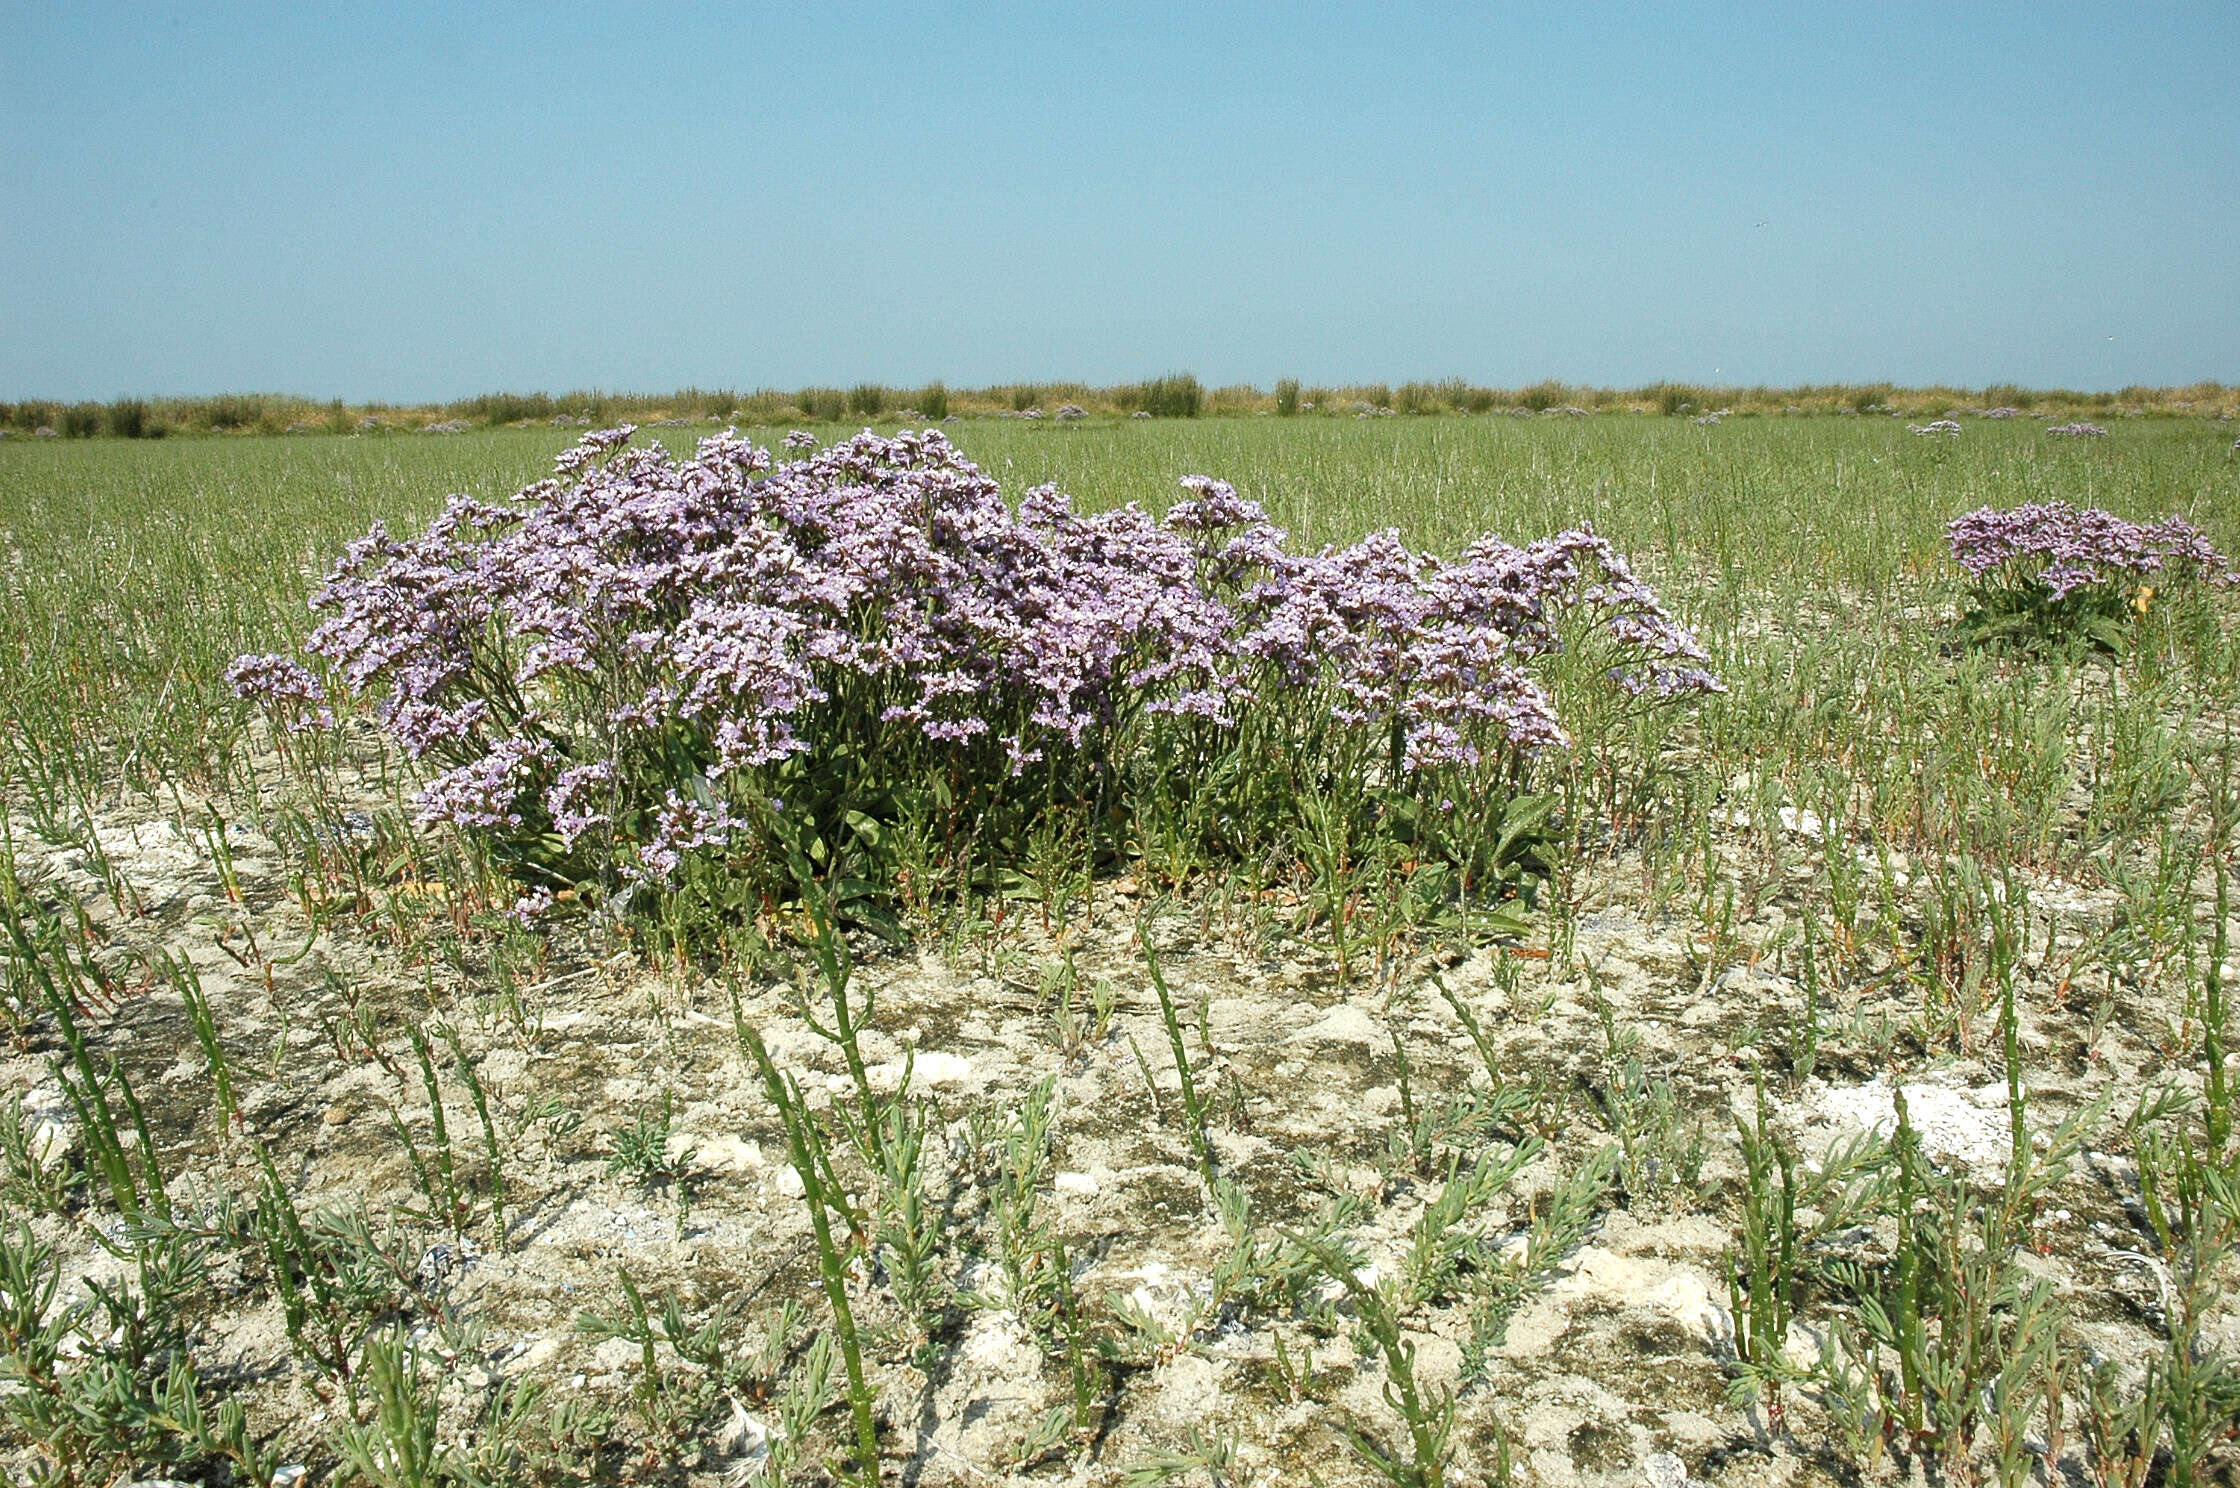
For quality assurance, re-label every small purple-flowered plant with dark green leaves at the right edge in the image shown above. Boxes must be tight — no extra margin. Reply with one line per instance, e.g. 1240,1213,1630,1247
1947,502,2240,652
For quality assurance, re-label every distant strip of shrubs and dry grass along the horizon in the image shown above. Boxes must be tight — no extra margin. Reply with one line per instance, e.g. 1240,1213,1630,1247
0,372,2240,439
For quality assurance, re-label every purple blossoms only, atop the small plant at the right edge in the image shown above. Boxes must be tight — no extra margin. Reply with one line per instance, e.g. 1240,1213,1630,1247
1947,502,2236,601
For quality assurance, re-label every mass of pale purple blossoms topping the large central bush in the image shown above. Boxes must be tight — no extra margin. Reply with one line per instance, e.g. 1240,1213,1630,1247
233,426,1720,881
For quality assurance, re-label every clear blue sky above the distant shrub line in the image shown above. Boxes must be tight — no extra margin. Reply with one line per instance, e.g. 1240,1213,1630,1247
0,0,2240,399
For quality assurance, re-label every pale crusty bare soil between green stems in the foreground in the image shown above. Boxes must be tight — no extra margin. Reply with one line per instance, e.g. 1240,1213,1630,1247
0,770,2240,1488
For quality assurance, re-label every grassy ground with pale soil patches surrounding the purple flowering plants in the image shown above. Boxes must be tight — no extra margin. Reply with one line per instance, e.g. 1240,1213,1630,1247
0,415,2240,1488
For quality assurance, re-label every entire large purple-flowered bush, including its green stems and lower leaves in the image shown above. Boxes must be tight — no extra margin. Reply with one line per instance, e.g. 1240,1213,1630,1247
231,426,1718,936
